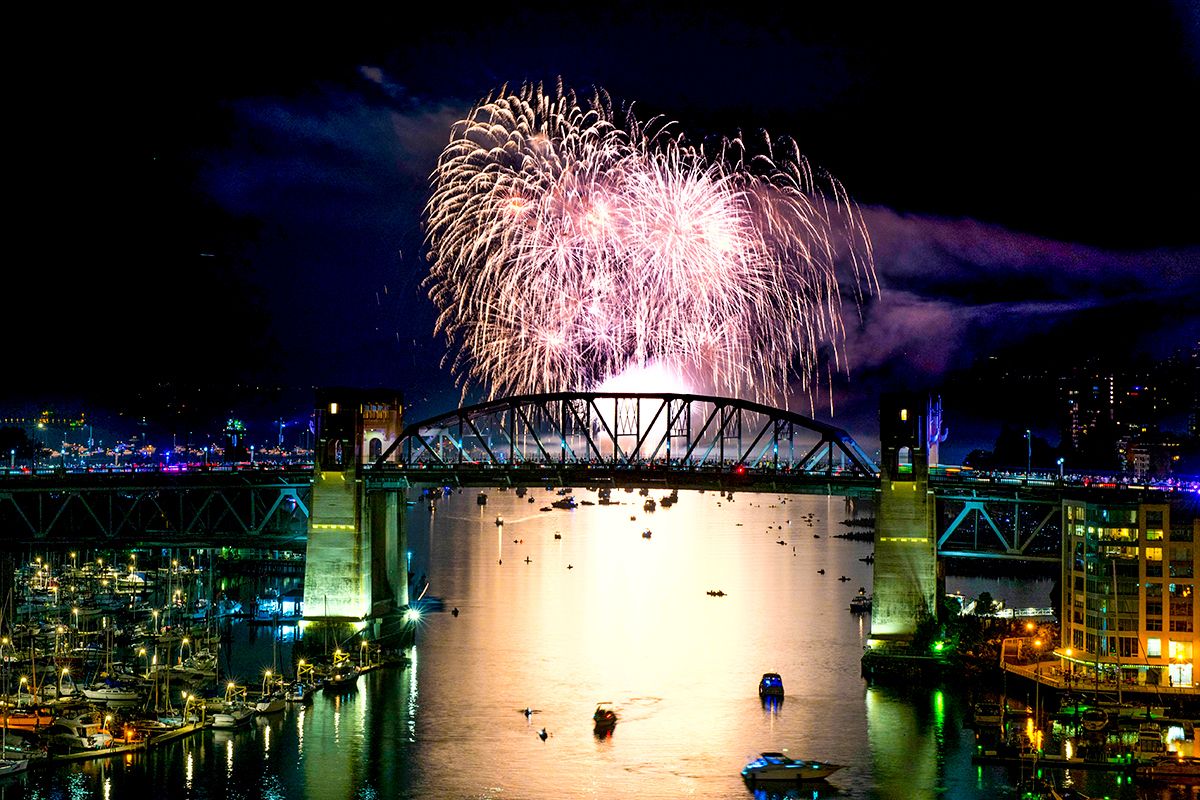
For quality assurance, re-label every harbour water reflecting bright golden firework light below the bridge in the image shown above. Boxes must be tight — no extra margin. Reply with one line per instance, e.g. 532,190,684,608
0,489,1196,800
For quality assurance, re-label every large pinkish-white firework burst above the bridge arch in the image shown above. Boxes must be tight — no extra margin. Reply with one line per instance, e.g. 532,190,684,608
426,79,878,405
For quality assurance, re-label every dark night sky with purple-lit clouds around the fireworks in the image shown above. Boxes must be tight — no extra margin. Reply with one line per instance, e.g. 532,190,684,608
9,1,1200,455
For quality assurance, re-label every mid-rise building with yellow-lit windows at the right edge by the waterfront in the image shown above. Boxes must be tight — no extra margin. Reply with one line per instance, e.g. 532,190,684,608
1057,500,1200,686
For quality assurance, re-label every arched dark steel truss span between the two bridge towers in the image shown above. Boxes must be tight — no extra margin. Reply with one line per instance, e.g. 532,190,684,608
368,392,878,494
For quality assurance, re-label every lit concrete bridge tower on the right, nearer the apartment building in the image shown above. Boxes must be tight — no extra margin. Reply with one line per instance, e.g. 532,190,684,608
871,393,946,643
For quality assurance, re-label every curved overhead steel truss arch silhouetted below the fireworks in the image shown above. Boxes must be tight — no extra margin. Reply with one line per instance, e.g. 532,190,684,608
373,392,878,479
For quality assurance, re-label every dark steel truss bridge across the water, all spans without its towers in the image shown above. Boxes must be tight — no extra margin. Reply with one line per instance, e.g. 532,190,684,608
0,392,1176,563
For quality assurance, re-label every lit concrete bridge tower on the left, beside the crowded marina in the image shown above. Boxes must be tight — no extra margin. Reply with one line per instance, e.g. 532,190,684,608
305,389,408,622
